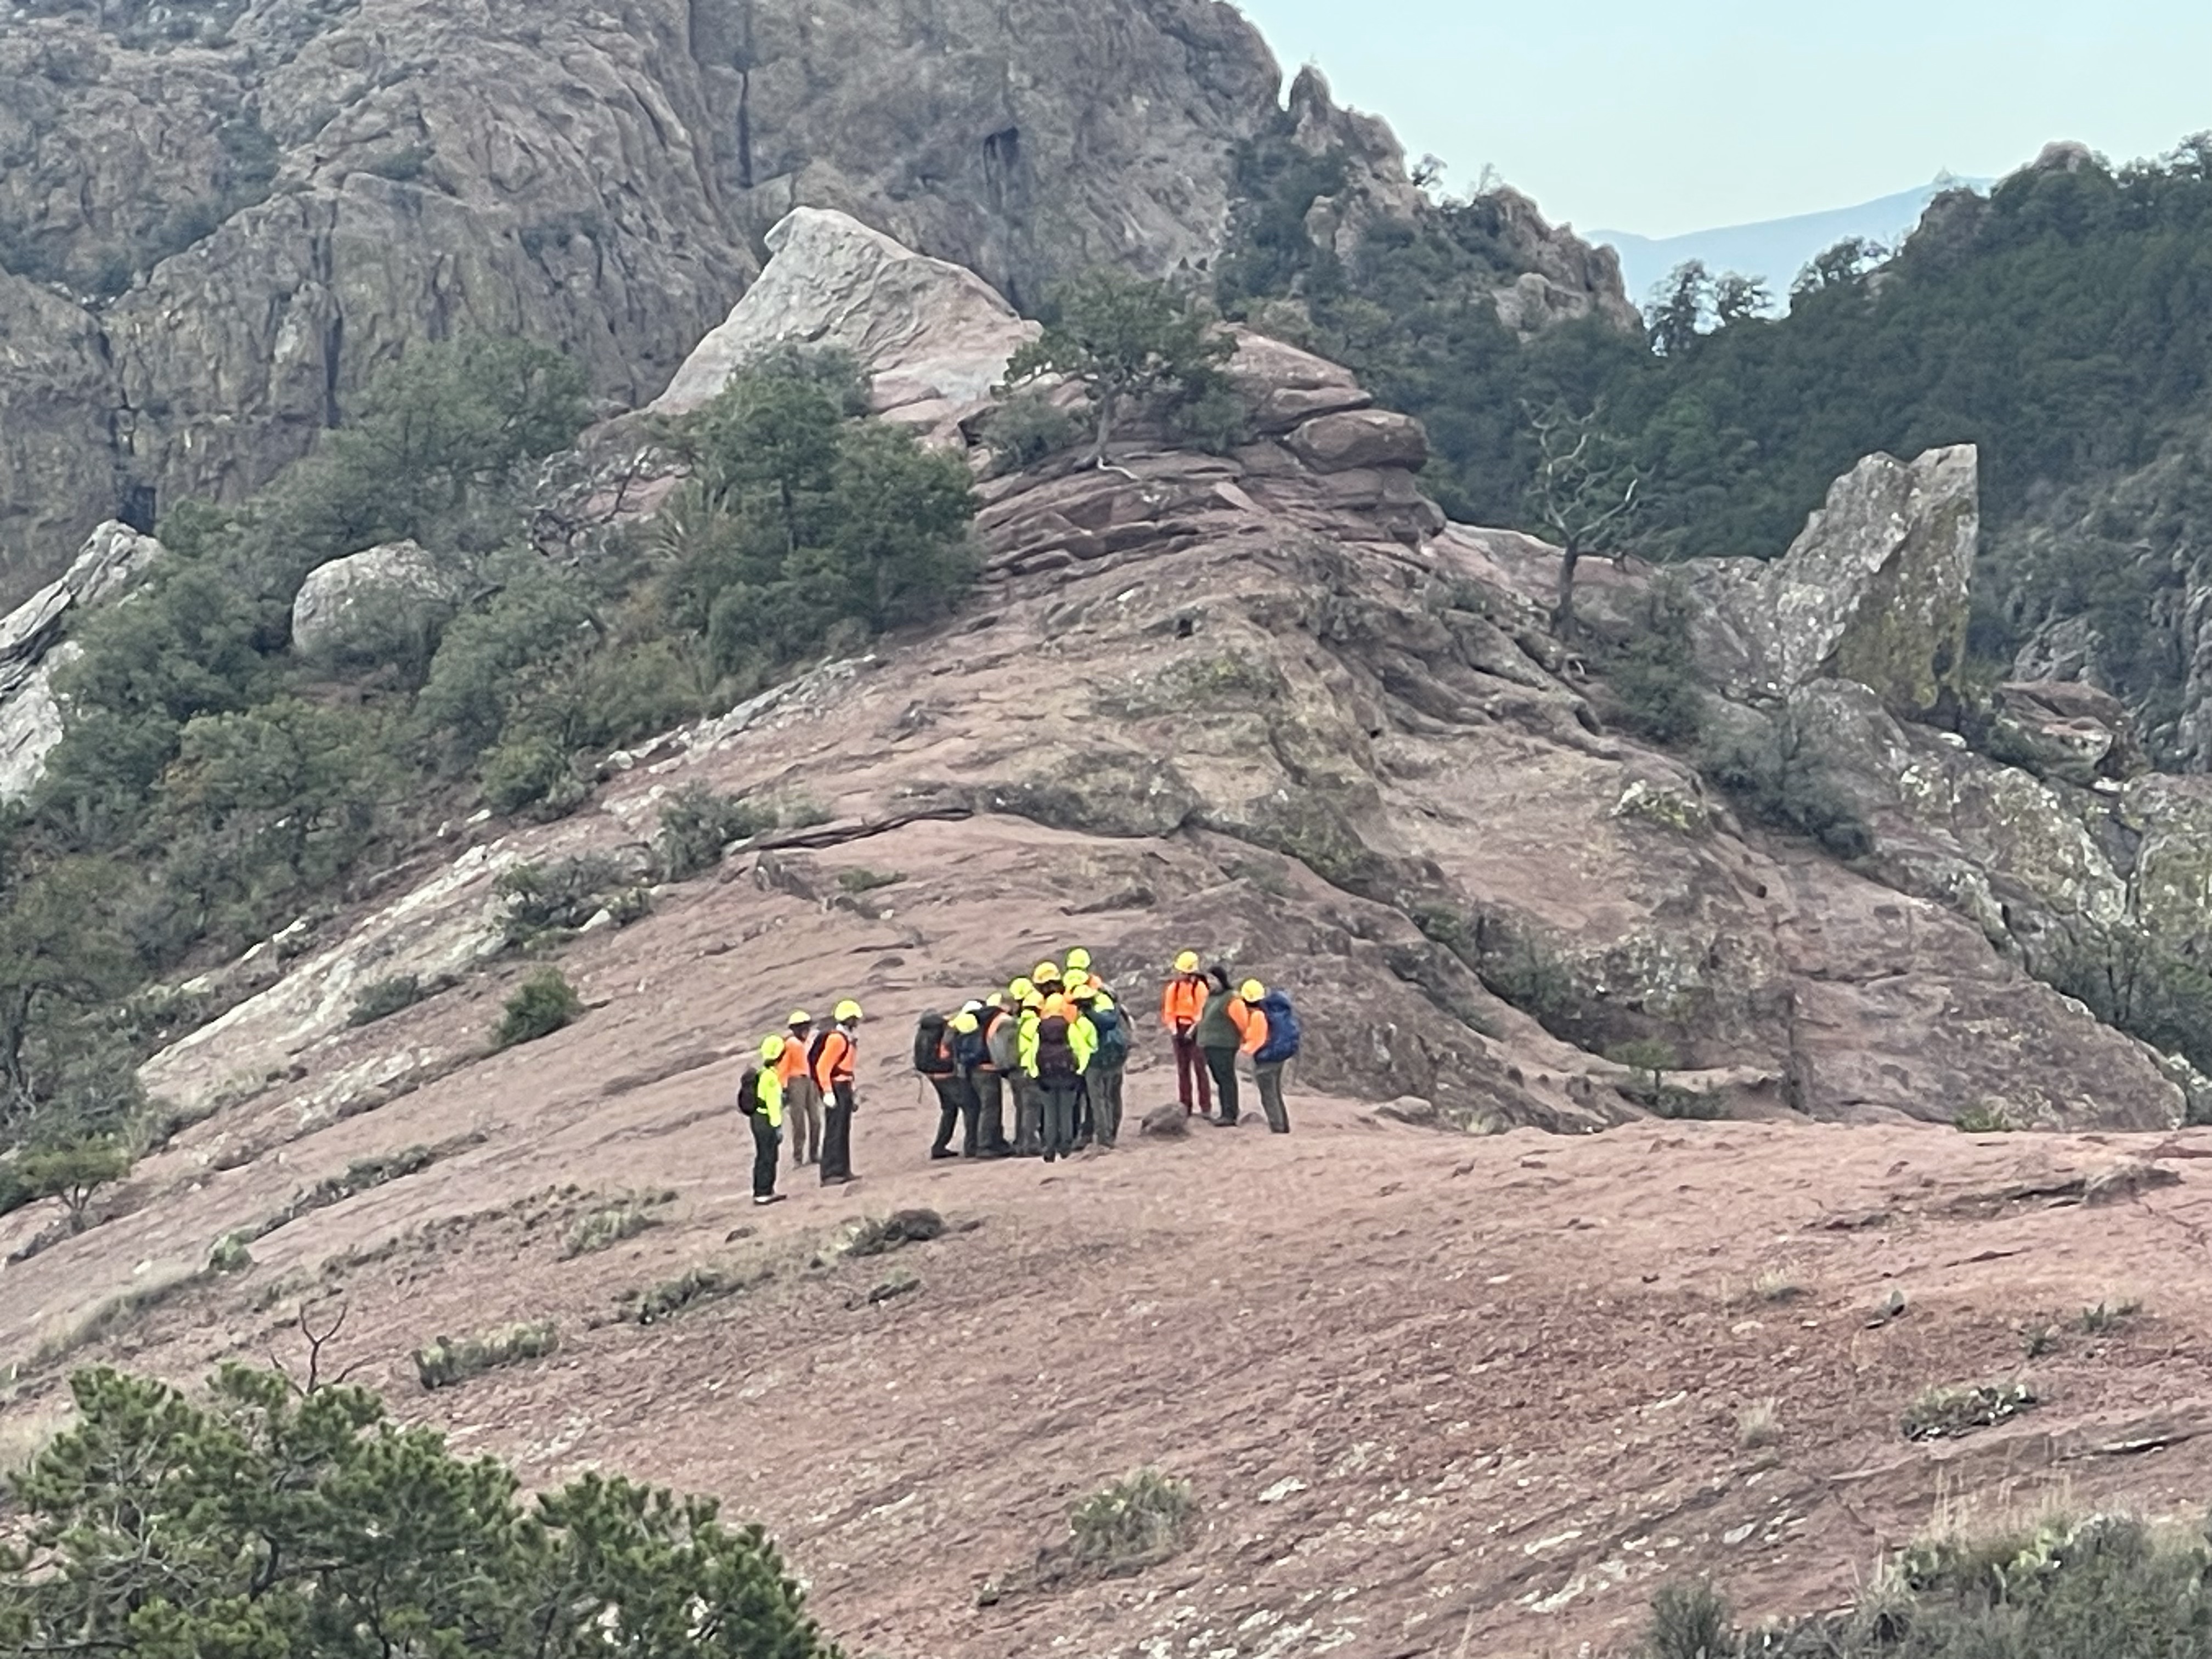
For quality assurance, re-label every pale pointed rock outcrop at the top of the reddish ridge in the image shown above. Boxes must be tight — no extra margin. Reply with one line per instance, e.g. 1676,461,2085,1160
652,208,1037,425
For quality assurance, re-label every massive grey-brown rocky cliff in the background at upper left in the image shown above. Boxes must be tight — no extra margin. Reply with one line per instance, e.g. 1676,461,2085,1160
0,0,1621,597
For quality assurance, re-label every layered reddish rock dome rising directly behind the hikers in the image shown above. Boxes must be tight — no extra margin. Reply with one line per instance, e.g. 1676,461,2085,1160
146,285,2186,1144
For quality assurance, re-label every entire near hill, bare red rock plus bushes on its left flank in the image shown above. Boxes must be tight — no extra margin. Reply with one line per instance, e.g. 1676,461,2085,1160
13,215,2212,1655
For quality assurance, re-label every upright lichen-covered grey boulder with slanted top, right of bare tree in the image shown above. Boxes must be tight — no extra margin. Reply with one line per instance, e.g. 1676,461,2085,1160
1683,444,1980,714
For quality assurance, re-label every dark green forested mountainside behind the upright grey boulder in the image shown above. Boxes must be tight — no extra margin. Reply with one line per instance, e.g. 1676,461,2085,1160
1226,142,2212,770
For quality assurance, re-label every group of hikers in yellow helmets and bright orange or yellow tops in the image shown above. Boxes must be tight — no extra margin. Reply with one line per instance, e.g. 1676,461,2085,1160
737,949,1301,1203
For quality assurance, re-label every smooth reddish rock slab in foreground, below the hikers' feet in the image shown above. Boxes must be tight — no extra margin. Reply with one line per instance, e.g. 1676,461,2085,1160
0,995,2212,1659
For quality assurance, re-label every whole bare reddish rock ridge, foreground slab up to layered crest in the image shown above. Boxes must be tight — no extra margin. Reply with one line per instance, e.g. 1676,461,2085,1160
0,204,2212,1659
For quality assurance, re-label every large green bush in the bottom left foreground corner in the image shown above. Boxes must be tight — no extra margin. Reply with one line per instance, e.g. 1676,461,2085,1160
0,1365,836,1659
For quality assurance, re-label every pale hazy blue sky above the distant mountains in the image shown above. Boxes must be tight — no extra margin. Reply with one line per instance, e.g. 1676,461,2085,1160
1237,0,2212,236
